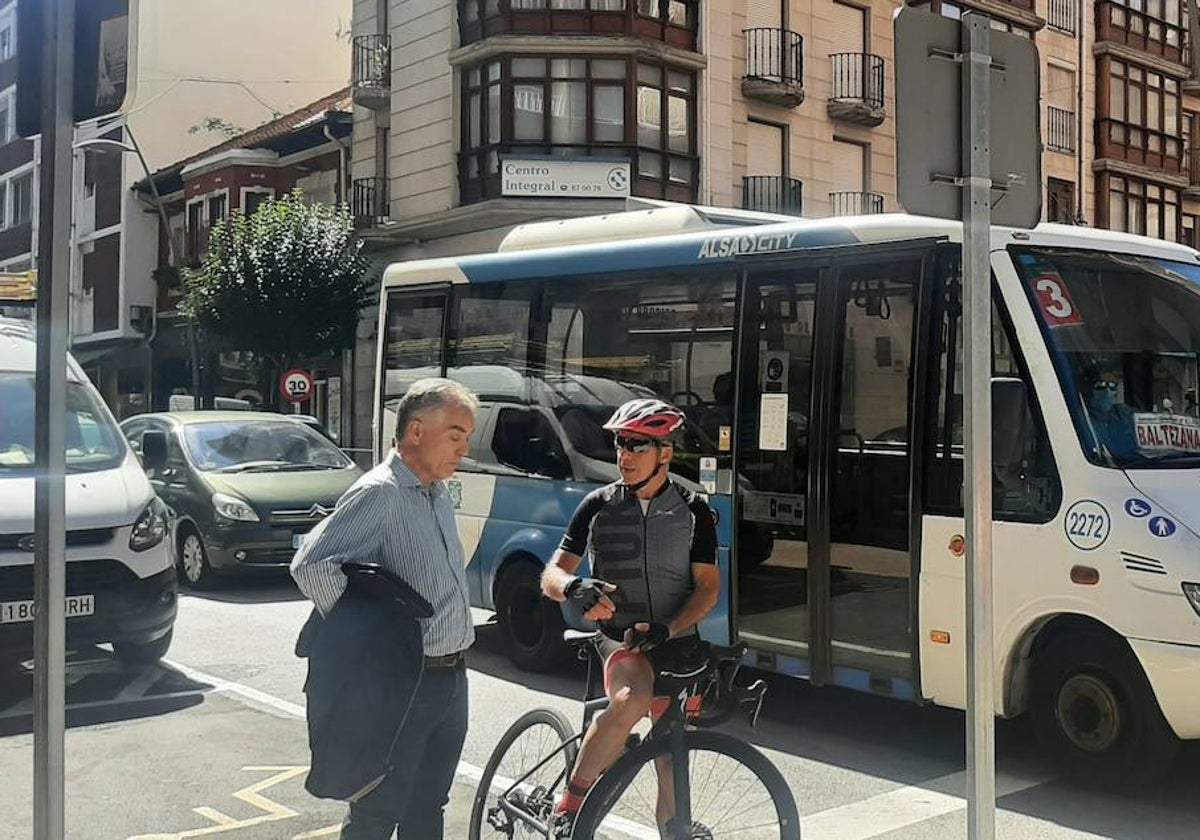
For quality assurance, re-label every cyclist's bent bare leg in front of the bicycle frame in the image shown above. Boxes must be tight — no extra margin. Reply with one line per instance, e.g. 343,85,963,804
575,652,654,784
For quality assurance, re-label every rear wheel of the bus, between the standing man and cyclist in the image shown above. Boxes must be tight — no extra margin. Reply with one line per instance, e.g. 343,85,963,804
496,563,568,671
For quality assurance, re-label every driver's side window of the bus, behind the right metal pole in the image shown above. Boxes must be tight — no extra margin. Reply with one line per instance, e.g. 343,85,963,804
926,265,1062,522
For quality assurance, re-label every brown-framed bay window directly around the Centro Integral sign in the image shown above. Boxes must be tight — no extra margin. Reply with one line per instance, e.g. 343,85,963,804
460,56,697,203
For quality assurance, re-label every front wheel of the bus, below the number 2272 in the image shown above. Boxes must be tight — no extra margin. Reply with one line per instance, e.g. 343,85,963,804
1030,632,1180,788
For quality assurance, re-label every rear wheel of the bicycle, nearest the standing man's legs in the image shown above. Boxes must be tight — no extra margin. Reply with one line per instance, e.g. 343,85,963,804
469,709,577,840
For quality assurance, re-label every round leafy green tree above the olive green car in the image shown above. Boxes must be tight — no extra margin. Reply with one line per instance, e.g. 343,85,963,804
180,190,372,405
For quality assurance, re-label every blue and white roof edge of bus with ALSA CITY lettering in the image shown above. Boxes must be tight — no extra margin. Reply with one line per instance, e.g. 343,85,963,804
383,208,1200,287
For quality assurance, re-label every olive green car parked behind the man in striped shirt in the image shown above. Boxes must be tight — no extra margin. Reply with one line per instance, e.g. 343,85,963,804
121,412,361,588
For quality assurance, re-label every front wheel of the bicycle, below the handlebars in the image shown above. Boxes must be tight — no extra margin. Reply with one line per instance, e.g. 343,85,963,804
571,732,800,840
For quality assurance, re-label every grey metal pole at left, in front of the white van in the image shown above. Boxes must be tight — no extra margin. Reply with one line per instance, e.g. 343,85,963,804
34,0,74,840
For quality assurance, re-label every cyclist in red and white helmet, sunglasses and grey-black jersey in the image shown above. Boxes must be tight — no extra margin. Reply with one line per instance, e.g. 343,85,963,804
541,400,721,830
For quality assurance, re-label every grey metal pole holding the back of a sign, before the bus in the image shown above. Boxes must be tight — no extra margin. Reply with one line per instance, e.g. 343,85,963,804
962,13,996,840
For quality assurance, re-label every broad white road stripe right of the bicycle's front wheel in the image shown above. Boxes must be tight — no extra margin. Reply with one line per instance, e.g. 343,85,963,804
800,772,1050,840
